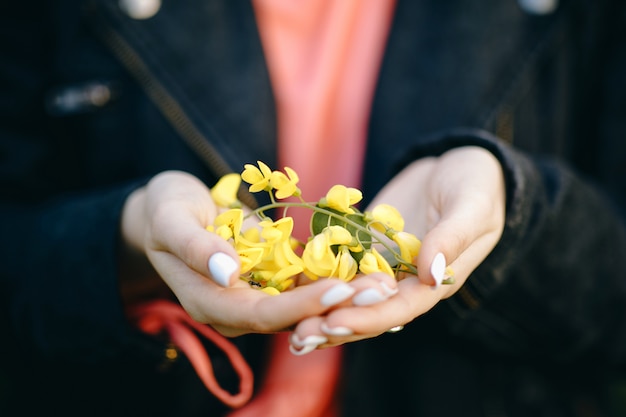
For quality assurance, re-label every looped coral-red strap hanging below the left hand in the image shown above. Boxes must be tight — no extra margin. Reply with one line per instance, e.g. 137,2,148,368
127,300,254,408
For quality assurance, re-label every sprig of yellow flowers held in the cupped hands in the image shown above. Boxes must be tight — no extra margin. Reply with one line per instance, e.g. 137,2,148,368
207,161,453,294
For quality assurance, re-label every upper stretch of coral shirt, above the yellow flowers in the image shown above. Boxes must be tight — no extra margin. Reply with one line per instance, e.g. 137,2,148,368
253,0,395,234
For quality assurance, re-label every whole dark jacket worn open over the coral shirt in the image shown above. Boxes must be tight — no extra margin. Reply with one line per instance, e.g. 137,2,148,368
0,0,626,416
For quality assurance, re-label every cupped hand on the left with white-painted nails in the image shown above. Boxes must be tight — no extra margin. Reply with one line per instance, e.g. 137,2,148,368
122,171,396,336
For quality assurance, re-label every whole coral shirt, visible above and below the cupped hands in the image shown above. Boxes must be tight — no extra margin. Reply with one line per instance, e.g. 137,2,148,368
232,0,395,417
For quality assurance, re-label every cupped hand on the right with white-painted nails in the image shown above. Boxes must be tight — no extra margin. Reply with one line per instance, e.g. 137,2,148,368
291,147,506,352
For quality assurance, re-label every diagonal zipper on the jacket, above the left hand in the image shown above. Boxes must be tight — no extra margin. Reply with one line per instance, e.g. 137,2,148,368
90,15,258,209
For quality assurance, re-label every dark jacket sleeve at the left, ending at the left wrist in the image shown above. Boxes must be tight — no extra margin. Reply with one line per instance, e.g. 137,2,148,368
0,185,146,360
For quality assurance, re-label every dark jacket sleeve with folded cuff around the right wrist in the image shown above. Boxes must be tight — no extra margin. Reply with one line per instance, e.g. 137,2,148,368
410,131,626,364
